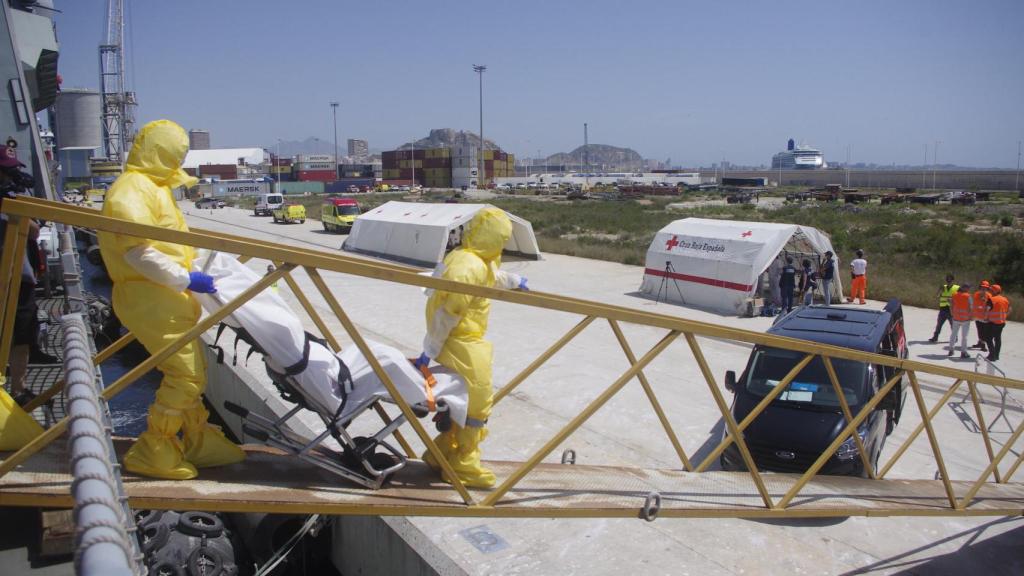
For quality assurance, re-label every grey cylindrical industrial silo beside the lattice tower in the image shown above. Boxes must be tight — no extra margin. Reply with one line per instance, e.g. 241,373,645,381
54,88,103,178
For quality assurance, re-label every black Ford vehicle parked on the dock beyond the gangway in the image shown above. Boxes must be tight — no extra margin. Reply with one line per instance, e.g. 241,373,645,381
721,299,907,476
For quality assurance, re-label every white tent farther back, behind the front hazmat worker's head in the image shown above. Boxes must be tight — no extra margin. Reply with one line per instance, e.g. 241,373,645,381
342,202,541,268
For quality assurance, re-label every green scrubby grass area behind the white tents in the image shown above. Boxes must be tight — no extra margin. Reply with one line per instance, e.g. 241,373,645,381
220,193,1024,321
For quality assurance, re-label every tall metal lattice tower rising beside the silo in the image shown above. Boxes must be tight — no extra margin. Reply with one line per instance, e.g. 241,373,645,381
99,0,135,164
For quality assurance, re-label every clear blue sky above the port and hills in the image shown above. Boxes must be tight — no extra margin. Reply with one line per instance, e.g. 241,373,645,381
55,0,1024,168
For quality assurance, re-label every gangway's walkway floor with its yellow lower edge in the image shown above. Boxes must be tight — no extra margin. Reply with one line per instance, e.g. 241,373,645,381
0,439,1024,518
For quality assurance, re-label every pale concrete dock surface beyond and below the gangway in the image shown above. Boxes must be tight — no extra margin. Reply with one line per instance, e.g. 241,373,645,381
180,202,1024,574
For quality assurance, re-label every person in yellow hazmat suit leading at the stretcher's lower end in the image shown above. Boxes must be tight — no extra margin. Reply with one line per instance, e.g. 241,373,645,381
415,208,528,488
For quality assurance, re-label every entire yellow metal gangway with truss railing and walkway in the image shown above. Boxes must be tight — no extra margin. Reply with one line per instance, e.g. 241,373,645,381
0,194,1024,520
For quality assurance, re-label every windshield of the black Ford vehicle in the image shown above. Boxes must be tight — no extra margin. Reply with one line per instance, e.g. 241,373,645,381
745,347,871,409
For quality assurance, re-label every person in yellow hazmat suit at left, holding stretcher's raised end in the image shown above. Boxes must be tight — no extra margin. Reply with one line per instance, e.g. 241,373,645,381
97,120,245,480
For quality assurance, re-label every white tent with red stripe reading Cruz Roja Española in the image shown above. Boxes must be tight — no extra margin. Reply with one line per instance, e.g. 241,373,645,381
640,218,843,315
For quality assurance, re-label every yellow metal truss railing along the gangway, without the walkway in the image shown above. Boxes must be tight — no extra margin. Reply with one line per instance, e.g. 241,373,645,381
0,199,1024,517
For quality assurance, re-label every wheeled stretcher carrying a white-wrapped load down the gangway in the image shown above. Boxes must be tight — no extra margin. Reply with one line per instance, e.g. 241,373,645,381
195,252,468,489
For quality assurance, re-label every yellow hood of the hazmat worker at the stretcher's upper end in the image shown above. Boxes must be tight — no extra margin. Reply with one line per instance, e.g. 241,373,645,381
126,120,199,189
